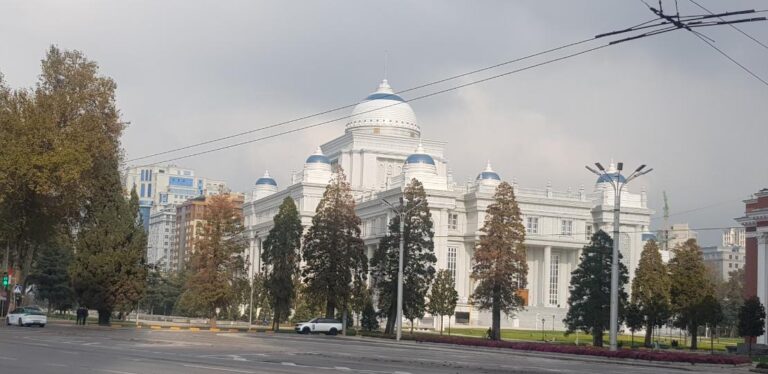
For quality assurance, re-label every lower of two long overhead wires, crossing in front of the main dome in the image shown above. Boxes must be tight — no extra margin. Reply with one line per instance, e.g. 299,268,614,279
153,44,611,163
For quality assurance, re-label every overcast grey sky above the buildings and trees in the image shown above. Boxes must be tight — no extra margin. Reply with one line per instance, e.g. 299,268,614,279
0,0,768,245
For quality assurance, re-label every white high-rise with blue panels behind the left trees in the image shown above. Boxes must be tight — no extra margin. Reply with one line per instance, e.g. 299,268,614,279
123,165,227,231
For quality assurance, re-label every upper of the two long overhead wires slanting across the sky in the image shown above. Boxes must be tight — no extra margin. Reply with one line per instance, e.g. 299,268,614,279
127,35,608,162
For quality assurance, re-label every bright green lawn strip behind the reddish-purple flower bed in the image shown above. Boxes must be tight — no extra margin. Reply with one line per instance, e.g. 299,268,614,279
436,328,742,351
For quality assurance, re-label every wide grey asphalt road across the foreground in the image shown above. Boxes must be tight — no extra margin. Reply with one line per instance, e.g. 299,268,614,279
0,325,747,374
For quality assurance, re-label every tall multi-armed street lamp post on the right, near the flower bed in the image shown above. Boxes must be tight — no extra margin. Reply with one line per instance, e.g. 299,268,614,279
586,162,653,351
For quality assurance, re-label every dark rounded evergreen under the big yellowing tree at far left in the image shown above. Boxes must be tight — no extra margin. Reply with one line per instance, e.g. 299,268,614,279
27,238,75,314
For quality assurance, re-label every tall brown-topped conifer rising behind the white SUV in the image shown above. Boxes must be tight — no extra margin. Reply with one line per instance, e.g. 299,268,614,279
302,166,368,318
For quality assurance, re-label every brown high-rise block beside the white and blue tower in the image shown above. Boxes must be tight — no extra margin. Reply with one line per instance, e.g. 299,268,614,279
169,194,245,271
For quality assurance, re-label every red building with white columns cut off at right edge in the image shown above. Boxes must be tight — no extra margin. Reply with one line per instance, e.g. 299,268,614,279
736,188,768,344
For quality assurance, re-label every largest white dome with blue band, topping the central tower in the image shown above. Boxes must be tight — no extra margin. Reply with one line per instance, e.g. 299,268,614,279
347,79,421,138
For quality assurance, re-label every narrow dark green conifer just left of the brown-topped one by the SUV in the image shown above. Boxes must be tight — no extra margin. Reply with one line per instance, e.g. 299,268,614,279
261,197,302,331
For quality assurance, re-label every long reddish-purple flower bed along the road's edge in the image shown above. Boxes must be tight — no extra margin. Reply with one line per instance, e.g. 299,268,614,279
415,335,751,365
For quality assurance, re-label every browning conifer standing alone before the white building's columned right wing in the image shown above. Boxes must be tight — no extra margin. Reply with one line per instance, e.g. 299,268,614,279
472,182,528,340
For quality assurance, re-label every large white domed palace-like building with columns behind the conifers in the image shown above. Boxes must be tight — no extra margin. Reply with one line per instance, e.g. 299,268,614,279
243,80,652,329
